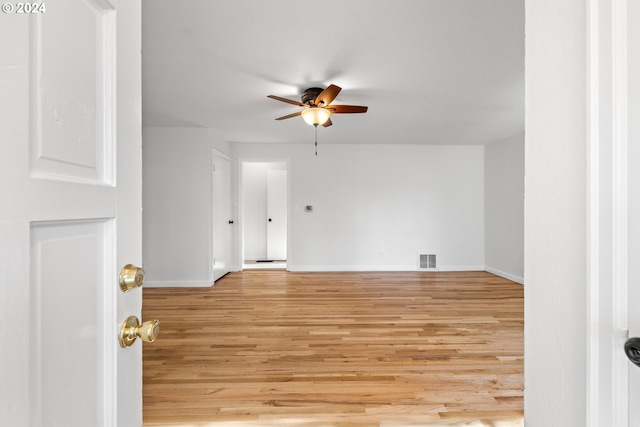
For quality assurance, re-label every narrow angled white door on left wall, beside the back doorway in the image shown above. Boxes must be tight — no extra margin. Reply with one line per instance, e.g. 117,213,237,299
212,151,235,281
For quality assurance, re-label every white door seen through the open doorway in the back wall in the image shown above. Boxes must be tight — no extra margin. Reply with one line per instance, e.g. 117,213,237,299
267,170,287,260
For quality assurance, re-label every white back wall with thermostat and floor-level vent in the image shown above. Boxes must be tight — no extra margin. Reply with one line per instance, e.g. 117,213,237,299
231,143,485,271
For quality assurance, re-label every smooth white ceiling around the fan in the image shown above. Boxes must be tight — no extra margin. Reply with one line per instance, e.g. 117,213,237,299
142,0,524,144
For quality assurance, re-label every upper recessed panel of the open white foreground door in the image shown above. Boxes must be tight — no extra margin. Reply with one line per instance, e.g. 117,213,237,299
30,1,115,182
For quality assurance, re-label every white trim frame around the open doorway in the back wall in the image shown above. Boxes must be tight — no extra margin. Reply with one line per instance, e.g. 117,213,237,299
236,157,293,271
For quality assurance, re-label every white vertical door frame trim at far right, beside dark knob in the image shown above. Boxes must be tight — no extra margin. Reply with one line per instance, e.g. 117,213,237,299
586,0,629,427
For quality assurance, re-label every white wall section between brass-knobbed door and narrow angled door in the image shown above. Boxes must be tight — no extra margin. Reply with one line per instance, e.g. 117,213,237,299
142,127,229,287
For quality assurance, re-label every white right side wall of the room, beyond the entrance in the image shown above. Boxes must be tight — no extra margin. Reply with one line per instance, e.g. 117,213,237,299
484,133,524,284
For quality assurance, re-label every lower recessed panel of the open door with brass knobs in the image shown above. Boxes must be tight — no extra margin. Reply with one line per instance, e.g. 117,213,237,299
29,221,116,426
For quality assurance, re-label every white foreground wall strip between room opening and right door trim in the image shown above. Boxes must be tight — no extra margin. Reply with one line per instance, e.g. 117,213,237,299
524,0,588,427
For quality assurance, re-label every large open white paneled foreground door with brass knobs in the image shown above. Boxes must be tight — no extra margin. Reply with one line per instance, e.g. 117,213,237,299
0,0,142,427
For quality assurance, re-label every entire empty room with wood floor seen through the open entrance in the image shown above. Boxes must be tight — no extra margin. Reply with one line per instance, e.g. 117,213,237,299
142,1,524,426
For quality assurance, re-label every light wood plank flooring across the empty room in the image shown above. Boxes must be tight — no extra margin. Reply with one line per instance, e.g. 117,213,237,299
143,271,524,426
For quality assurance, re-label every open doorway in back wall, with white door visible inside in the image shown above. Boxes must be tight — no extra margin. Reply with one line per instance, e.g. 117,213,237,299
240,161,289,270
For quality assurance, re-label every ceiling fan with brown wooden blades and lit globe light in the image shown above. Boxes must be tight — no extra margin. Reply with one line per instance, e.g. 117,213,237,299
267,84,367,128
